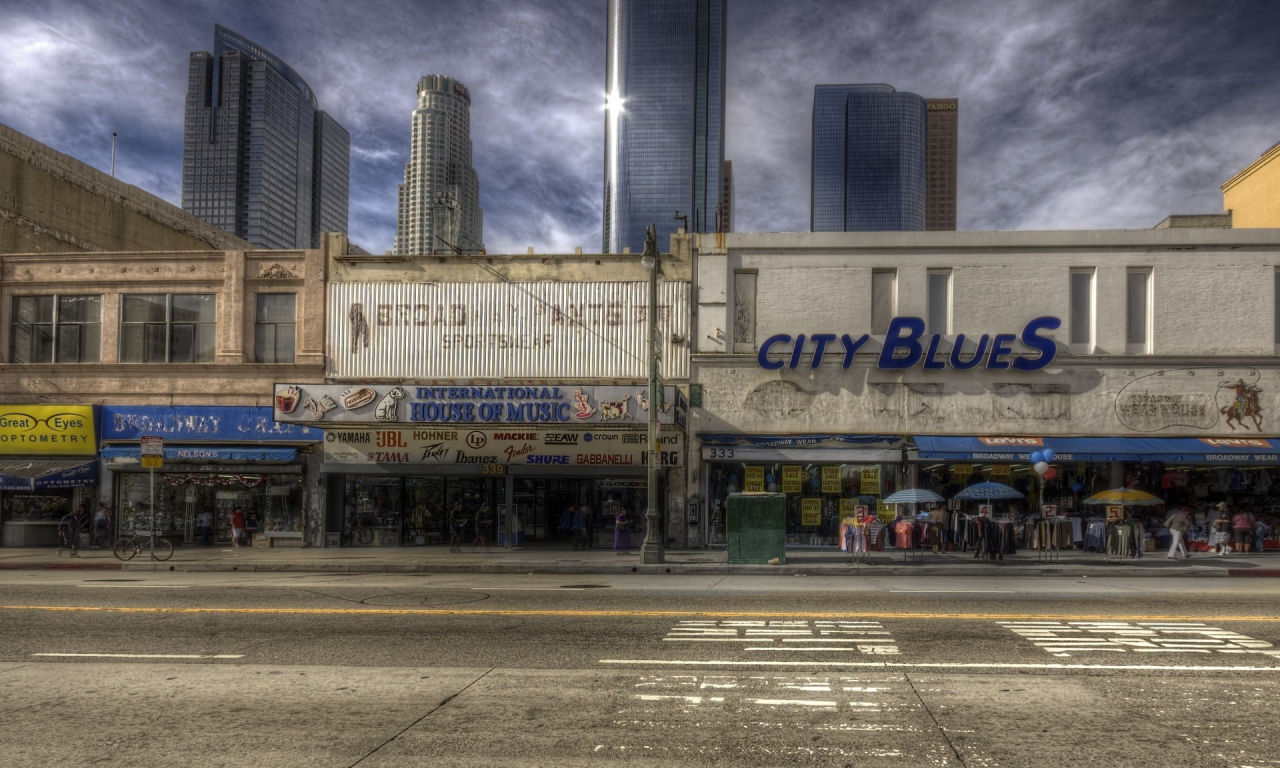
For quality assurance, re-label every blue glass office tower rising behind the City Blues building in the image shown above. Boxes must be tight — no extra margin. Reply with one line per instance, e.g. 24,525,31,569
810,84,928,232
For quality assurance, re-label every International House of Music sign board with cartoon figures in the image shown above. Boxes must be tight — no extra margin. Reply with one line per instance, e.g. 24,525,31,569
274,384,676,426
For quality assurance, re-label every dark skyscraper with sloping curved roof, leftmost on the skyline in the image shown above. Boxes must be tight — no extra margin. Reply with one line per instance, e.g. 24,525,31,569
182,26,351,248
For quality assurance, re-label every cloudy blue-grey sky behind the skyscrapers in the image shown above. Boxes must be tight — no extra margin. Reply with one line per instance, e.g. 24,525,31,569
0,0,1280,253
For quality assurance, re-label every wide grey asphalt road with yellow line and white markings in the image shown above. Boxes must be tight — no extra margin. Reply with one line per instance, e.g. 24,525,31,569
0,572,1280,768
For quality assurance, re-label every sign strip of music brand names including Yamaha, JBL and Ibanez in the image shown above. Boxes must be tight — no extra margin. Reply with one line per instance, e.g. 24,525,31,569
324,426,685,467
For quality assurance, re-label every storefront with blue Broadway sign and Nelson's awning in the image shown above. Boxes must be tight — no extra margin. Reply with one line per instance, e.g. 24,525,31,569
101,406,323,547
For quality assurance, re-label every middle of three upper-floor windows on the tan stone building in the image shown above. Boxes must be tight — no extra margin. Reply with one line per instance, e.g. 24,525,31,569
120,293,218,362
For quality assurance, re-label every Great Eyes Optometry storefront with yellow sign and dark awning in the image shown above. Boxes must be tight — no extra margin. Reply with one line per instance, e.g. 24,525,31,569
0,404,99,547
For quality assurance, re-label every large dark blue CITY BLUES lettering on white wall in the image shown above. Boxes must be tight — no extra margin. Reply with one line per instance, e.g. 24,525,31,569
756,317,1062,371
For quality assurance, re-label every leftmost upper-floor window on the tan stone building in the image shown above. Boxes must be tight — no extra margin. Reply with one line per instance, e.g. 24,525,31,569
9,296,102,364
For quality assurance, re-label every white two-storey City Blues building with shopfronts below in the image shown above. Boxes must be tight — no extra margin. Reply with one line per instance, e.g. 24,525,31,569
690,229,1280,547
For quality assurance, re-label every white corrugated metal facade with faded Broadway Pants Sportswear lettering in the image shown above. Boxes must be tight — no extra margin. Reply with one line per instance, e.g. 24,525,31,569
326,282,690,380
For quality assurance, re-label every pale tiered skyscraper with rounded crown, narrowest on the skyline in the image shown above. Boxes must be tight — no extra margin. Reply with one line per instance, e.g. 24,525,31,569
396,74,484,256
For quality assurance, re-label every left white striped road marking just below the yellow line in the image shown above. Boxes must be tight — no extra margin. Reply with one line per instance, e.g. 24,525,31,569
663,620,900,655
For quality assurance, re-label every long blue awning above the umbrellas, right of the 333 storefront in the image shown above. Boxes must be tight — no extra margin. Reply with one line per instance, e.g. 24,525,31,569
913,435,1280,465
